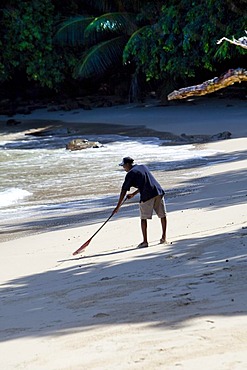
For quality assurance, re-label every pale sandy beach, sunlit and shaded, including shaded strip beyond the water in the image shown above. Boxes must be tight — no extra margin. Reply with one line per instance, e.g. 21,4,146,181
0,99,247,370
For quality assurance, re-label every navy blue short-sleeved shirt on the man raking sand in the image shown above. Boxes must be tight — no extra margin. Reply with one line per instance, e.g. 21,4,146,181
122,164,165,202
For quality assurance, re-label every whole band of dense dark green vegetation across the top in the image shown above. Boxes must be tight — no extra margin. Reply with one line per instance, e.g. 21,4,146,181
0,0,247,99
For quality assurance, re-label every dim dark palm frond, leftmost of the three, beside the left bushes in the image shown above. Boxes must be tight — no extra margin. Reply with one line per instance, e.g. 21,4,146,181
54,16,94,46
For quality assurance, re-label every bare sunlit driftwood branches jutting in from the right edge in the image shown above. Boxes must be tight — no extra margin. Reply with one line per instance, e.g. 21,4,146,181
167,31,247,100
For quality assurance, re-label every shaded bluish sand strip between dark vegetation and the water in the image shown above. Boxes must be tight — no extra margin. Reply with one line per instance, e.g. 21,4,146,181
0,98,247,138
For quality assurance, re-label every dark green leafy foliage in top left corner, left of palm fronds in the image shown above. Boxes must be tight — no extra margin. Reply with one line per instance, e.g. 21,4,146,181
0,0,63,88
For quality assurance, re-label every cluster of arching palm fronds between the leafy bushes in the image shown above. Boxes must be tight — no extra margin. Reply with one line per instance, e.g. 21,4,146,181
56,0,154,78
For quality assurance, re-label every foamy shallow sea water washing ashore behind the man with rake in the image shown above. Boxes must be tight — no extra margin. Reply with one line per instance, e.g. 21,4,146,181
0,131,223,241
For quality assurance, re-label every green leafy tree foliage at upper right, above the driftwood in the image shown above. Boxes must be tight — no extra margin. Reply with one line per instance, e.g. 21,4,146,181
124,0,247,80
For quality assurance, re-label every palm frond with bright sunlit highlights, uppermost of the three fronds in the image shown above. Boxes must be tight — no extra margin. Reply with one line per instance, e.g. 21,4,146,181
84,12,137,45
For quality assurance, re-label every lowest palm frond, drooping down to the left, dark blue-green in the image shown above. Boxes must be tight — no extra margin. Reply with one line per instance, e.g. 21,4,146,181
74,36,127,78
